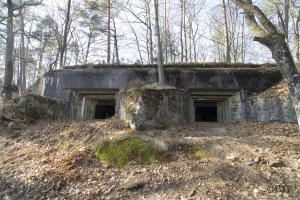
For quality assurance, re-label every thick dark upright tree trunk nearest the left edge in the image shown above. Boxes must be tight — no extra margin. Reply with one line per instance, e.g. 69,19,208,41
3,0,14,100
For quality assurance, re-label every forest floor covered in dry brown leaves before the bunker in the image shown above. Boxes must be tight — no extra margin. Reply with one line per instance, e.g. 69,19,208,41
0,119,300,200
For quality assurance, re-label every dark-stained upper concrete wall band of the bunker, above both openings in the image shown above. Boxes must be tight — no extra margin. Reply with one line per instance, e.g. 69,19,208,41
43,65,282,100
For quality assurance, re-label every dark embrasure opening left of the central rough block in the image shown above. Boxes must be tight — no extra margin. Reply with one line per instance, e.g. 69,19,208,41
95,101,115,119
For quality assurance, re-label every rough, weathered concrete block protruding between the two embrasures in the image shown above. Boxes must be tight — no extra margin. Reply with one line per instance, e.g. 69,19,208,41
117,86,193,130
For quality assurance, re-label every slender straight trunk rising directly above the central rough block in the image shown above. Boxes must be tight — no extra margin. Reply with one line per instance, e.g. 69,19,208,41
154,0,166,85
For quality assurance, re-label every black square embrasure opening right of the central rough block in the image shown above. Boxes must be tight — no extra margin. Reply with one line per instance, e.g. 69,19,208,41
195,102,218,122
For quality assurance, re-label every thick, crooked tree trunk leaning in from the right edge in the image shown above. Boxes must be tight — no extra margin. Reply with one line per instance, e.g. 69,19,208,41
233,0,300,130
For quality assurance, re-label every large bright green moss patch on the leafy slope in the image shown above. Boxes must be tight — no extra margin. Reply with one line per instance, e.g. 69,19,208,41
94,138,168,167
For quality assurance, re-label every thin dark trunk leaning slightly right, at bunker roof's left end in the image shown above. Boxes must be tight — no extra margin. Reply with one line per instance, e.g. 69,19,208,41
59,0,71,69
